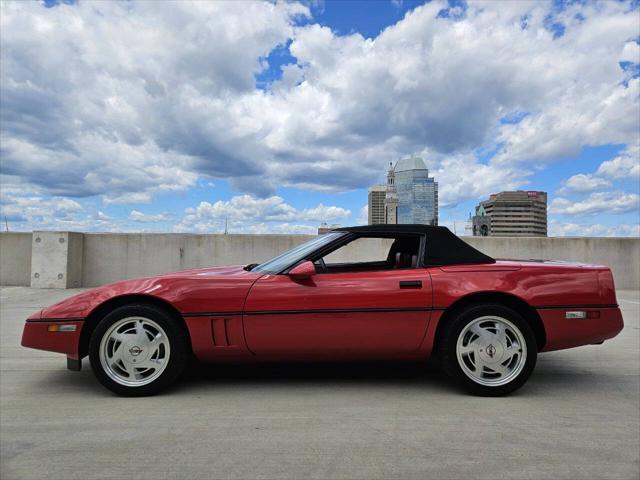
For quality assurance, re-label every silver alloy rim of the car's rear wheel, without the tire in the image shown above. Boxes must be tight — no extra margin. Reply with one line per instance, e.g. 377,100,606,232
456,315,527,387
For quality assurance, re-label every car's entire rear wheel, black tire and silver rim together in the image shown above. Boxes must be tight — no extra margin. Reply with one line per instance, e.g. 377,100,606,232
441,305,538,396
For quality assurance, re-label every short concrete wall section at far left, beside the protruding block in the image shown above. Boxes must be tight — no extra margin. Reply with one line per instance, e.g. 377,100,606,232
0,232,32,285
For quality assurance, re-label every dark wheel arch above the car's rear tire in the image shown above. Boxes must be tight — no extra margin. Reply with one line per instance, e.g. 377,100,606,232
433,292,547,352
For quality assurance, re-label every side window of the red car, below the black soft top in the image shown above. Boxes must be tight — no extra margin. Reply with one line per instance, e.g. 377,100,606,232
315,235,420,273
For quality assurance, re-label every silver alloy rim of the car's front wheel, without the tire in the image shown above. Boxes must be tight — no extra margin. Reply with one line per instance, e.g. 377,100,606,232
99,317,171,387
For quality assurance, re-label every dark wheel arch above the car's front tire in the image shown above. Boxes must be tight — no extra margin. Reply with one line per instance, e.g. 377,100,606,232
78,294,191,358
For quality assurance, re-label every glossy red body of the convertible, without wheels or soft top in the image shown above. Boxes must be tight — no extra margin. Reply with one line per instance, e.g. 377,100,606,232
22,255,623,361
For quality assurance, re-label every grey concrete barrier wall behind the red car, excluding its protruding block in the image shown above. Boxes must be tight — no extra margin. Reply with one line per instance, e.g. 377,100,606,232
0,233,640,289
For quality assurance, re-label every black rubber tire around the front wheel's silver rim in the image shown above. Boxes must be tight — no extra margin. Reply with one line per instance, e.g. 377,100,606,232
89,304,191,397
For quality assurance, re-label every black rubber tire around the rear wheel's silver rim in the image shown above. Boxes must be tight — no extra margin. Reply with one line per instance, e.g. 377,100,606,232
439,304,538,397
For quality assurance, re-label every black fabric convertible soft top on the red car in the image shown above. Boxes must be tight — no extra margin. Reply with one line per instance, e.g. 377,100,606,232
334,224,496,265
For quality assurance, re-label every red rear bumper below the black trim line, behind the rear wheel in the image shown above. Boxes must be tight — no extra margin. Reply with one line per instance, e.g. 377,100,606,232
537,306,624,352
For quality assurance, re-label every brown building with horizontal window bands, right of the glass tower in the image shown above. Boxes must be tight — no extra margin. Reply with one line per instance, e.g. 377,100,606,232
472,191,547,237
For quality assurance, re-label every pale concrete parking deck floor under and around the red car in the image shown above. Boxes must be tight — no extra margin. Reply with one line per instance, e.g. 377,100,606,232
0,287,640,480
